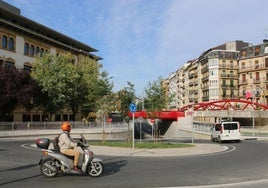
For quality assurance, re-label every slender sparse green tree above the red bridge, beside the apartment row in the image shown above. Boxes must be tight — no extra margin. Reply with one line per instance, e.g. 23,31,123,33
145,77,168,111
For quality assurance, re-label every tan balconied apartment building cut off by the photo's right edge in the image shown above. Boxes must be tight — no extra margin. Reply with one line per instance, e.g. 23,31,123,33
239,40,268,105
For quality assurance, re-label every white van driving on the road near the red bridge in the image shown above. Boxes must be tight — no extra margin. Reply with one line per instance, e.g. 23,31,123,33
211,121,241,143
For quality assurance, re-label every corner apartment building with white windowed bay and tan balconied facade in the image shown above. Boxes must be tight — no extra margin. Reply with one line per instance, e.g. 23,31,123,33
202,50,239,101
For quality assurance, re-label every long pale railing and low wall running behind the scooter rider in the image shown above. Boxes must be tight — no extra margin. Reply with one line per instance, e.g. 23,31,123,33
0,122,130,139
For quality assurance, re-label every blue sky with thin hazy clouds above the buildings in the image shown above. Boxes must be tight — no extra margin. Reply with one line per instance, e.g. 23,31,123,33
4,0,268,96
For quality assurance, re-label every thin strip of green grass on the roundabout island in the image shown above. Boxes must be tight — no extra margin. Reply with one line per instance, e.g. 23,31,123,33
89,141,193,149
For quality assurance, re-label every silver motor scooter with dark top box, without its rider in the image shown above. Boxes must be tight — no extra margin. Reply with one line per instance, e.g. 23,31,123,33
36,135,104,177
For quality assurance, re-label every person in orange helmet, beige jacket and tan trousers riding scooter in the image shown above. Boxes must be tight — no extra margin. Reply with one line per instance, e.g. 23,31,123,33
58,122,82,172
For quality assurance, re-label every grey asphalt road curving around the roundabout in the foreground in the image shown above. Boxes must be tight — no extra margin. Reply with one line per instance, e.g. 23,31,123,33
0,140,268,188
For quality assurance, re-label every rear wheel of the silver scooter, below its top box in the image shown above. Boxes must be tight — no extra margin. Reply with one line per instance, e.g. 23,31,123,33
40,158,59,178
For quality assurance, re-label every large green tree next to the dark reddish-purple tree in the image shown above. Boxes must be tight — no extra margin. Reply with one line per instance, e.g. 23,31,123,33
31,54,70,119
